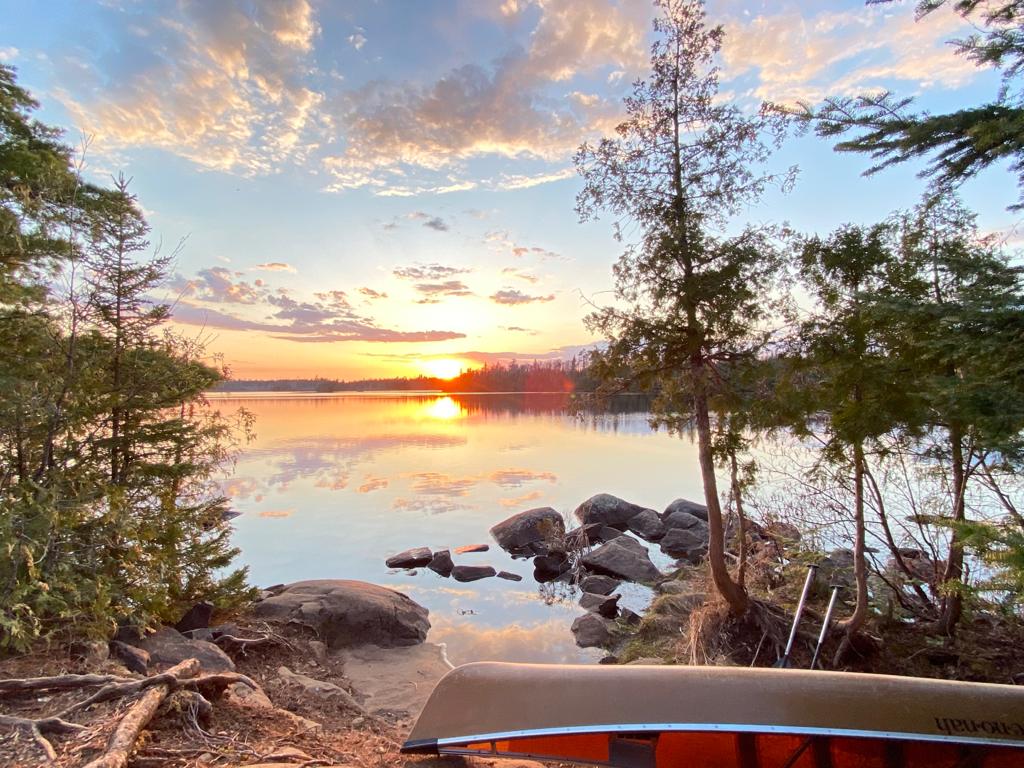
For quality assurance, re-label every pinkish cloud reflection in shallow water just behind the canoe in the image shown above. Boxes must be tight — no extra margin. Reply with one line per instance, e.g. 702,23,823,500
427,615,603,666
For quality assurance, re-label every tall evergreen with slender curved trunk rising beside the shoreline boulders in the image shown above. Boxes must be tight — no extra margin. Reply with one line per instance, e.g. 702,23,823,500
575,0,787,613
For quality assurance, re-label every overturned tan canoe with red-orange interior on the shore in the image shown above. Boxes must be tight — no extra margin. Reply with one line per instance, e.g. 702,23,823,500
402,662,1024,768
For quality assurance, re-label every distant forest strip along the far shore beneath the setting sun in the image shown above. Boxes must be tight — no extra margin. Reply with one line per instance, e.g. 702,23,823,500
207,357,598,392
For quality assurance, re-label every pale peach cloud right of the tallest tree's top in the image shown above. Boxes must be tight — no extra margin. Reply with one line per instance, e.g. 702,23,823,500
722,5,981,102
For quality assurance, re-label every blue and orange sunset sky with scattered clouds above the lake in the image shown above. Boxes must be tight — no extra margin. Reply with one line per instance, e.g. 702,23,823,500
0,0,1017,379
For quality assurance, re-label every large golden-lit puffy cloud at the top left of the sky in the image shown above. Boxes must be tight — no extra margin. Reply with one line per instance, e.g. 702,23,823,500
54,0,323,174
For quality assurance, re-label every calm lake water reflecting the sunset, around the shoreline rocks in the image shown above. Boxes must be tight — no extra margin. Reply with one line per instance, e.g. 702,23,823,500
211,393,701,665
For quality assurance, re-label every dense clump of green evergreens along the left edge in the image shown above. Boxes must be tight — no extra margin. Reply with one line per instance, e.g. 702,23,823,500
0,68,249,649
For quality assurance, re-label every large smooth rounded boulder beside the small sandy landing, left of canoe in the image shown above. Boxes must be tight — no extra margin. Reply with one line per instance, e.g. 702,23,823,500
254,579,430,648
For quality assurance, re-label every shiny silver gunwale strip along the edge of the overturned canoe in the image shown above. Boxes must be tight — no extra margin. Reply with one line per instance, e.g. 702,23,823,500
401,723,1024,755
